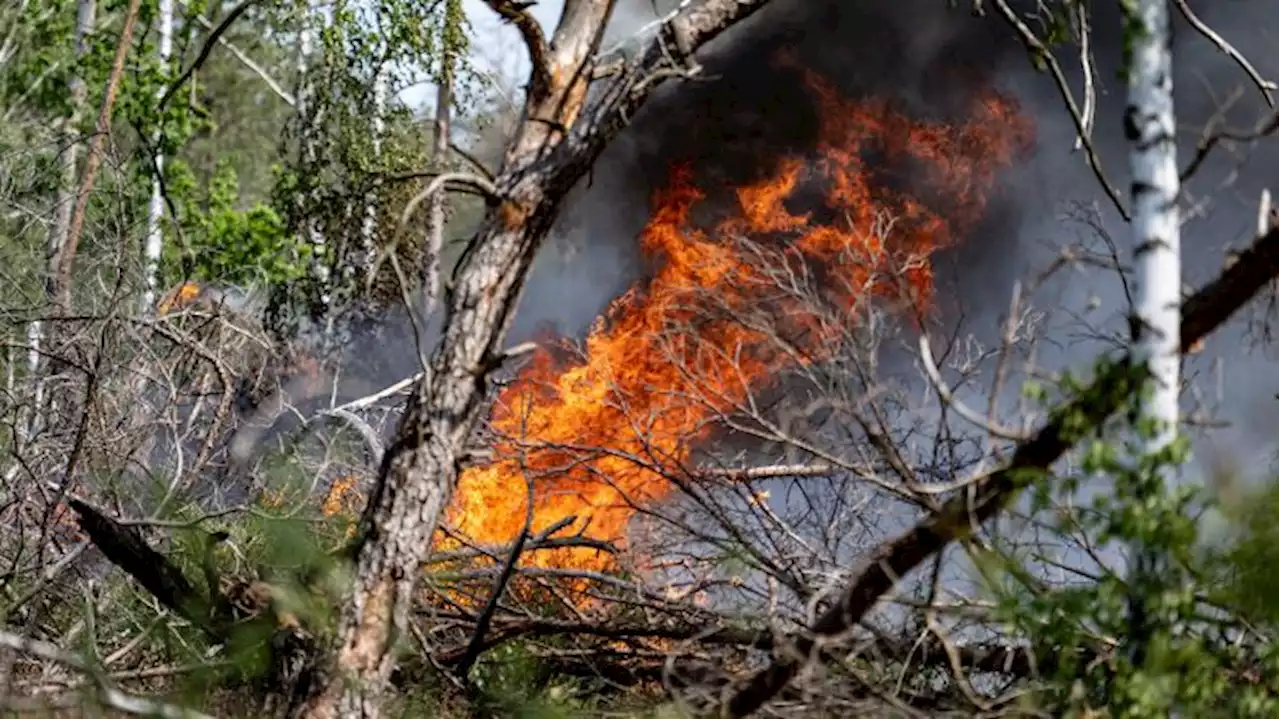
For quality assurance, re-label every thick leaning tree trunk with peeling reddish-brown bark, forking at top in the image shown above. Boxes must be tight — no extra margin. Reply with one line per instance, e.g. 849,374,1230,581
296,0,768,719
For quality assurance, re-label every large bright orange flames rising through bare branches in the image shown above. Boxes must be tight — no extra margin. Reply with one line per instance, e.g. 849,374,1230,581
449,70,1033,569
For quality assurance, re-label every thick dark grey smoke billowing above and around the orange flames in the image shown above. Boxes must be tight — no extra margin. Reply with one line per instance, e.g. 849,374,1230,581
512,0,1280,475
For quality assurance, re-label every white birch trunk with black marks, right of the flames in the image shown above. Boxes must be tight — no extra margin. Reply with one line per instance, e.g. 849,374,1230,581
1125,0,1183,663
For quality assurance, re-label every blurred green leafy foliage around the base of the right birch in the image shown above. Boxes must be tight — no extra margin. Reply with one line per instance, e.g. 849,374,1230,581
979,366,1280,718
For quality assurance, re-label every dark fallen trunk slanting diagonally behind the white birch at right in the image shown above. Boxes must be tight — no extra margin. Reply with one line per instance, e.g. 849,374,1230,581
723,221,1280,716
